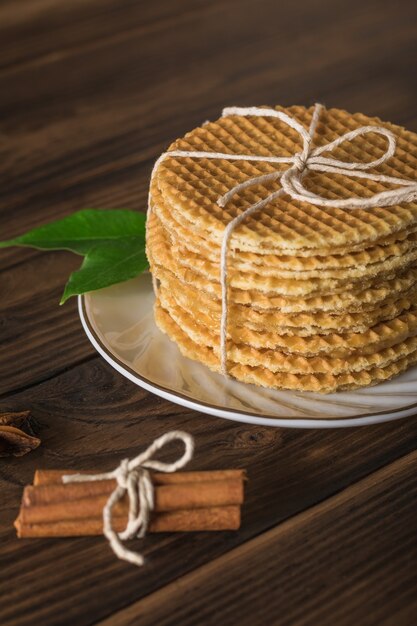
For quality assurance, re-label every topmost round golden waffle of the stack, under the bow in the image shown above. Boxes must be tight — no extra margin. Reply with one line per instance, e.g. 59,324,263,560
155,107,417,253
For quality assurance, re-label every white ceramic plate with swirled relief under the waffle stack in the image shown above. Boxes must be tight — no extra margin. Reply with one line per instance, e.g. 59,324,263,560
79,273,417,428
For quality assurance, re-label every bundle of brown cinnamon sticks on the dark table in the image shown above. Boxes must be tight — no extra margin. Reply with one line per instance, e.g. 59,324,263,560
15,470,245,537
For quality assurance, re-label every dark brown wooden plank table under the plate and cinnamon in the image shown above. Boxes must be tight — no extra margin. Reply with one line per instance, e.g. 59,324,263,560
0,0,417,626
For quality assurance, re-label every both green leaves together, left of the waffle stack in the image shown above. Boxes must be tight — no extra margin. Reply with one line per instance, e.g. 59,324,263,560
0,209,148,304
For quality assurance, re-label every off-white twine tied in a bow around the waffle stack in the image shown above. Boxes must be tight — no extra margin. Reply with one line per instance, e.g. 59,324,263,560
148,104,417,376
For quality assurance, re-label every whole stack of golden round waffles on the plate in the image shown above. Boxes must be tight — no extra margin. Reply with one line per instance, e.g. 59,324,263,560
147,106,417,393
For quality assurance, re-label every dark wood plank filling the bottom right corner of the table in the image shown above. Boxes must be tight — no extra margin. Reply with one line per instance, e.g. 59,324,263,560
100,452,417,626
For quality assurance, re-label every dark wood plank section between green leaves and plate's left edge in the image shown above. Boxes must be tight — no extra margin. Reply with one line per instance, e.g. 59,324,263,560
0,252,96,397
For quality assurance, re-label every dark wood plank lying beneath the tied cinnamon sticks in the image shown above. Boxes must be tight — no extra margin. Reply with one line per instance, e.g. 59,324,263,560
0,360,417,626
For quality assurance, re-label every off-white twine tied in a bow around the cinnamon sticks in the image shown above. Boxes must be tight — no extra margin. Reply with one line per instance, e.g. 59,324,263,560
62,430,194,566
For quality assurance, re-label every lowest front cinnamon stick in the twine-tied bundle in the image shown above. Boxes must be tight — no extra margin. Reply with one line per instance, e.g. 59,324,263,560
15,506,240,538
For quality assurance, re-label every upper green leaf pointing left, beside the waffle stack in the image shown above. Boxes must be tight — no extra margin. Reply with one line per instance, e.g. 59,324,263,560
0,209,146,255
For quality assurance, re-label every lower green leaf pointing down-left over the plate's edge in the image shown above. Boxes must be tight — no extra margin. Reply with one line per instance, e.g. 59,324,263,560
60,238,148,304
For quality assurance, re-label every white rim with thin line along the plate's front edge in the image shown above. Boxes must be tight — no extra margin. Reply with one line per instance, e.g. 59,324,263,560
78,294,417,429
